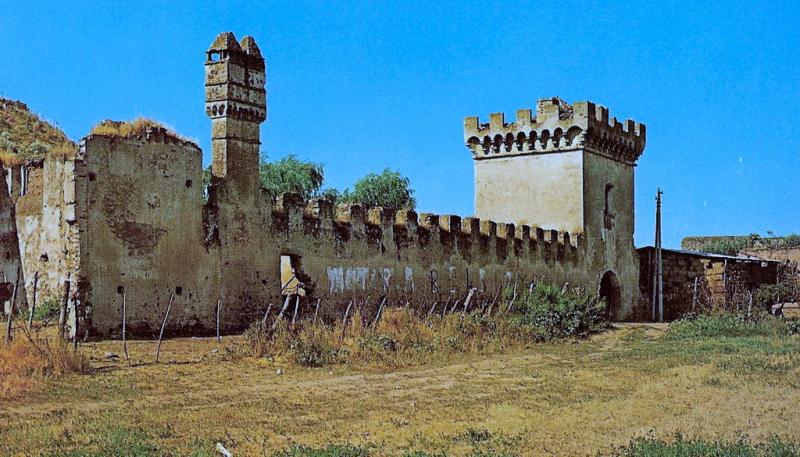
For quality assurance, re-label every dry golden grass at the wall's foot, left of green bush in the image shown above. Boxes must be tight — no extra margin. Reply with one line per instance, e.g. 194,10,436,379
253,307,534,369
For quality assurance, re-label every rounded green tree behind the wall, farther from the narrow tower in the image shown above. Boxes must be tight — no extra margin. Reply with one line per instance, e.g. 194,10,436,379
339,168,417,209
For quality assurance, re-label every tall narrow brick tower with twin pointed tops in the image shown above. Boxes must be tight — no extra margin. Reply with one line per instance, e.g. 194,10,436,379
205,32,267,198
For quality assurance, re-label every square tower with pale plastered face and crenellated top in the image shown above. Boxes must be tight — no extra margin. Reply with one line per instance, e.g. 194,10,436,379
464,98,646,318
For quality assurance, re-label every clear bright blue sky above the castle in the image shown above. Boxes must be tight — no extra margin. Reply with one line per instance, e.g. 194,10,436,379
0,1,800,247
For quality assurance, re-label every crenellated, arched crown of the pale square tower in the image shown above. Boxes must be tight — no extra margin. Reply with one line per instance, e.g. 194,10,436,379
464,97,646,163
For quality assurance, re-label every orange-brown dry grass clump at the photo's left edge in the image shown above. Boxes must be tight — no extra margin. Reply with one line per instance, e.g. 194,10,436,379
0,335,89,399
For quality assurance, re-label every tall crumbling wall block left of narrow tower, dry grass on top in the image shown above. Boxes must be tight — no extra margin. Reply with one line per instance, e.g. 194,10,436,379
77,129,219,336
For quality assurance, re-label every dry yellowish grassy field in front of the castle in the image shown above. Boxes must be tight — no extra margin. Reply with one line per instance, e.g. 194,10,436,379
0,325,800,456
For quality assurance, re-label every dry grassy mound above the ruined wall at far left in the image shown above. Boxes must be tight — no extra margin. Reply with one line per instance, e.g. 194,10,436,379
0,97,77,165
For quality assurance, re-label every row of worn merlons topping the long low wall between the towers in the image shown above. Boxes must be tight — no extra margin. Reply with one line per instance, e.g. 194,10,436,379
272,193,585,263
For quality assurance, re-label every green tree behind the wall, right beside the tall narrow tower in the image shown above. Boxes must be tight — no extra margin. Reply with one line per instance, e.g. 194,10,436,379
258,155,325,199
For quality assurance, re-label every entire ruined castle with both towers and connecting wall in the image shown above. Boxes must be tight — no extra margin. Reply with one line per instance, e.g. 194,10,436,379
4,33,646,336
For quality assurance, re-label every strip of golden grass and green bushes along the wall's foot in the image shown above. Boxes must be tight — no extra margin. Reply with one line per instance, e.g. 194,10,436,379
245,285,607,367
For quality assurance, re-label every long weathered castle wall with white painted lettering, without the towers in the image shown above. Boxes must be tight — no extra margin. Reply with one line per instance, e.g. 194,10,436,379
69,128,597,336
